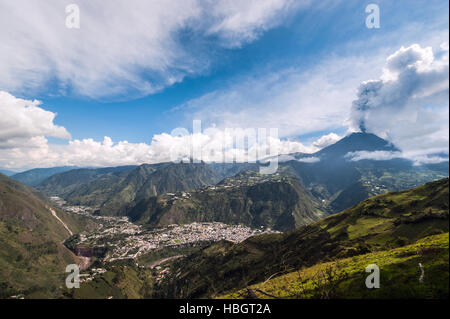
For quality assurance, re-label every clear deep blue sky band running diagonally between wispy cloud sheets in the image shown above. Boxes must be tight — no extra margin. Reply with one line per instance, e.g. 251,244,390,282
41,1,448,142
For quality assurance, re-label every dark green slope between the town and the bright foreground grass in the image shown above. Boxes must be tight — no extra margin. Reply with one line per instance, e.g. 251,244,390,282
161,179,449,298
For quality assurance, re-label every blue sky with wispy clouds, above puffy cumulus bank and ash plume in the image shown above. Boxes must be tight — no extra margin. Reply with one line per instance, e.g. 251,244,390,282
0,0,448,167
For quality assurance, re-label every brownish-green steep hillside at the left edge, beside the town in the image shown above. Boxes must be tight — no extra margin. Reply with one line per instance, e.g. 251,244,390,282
0,175,96,298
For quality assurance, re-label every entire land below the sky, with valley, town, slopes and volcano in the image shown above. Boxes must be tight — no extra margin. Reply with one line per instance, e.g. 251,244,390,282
0,133,448,299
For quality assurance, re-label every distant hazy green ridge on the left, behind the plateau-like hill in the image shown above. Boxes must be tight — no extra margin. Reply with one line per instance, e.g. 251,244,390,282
38,163,220,215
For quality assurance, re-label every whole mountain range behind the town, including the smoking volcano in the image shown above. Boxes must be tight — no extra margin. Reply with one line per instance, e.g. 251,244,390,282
9,133,442,230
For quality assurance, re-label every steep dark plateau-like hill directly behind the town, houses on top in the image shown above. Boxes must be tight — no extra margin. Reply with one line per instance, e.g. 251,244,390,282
127,171,324,231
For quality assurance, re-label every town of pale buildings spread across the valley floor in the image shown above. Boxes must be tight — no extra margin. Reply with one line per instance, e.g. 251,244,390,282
52,197,276,263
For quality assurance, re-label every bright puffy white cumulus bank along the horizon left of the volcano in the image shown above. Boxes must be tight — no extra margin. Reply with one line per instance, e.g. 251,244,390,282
0,91,320,168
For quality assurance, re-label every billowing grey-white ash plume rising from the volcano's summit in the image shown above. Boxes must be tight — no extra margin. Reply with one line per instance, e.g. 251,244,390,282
350,44,449,136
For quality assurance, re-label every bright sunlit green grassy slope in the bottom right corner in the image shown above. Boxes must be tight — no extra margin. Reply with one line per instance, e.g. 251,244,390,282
219,233,449,299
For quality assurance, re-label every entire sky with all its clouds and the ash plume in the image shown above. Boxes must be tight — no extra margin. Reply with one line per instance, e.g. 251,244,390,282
0,0,449,170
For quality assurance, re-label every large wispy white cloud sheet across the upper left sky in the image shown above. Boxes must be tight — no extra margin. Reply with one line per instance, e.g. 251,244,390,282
0,0,308,98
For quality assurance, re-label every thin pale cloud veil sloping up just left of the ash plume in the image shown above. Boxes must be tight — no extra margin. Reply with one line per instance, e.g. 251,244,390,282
174,10,448,137
